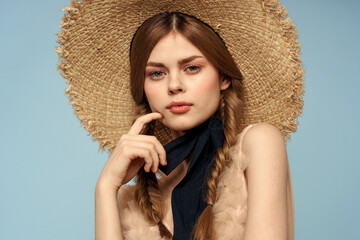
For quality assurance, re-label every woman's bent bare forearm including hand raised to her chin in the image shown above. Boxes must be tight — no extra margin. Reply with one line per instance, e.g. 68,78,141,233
95,113,166,240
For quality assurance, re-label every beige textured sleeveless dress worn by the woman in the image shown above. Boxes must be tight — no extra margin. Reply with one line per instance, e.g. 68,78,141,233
118,124,294,240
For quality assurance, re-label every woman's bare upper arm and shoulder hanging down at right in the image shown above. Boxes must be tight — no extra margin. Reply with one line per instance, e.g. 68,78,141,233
243,123,288,240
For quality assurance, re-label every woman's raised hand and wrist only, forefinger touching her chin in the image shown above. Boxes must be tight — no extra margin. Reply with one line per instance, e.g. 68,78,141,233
98,113,167,191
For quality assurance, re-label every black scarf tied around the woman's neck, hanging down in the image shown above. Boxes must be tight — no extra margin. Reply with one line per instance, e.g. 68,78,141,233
159,115,225,240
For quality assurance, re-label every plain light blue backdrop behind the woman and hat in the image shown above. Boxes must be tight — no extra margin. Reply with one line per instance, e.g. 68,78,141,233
0,0,360,240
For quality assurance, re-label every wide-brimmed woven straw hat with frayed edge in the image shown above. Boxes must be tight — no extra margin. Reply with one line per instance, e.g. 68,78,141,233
56,0,304,151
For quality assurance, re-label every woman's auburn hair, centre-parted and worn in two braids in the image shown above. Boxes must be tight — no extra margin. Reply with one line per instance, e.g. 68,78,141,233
130,12,242,240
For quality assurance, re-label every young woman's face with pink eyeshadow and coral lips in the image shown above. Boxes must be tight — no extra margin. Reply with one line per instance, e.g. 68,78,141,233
144,32,230,136
